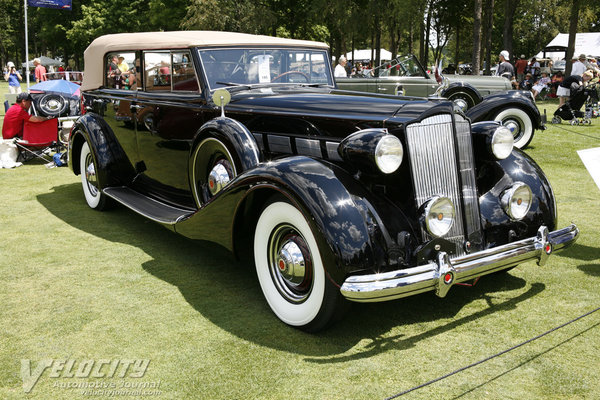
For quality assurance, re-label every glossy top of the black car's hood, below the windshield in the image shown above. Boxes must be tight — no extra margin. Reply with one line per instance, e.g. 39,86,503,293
227,88,439,121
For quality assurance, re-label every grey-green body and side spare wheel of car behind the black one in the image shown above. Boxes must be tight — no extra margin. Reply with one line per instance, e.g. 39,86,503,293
335,54,512,110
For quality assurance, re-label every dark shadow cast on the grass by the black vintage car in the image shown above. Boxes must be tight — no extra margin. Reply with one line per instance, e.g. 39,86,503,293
37,183,545,363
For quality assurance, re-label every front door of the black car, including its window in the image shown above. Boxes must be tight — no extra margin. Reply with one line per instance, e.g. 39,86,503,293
134,50,205,206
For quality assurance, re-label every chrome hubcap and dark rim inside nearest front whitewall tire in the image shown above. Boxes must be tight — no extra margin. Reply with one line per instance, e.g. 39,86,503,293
269,225,313,303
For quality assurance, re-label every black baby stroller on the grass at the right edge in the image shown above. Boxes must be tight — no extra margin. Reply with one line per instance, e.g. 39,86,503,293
552,83,598,125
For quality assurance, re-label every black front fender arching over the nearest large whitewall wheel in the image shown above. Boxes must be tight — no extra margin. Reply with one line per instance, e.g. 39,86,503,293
175,156,404,285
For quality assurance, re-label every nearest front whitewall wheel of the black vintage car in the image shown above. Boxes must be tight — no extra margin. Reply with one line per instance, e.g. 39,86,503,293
254,201,343,332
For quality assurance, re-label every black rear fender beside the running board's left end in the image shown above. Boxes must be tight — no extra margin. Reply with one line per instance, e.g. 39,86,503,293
68,113,135,188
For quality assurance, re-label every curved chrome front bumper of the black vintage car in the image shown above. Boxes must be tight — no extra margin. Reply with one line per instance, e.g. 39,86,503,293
340,225,579,302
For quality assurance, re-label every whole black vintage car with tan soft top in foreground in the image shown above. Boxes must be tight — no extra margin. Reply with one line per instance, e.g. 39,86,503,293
69,31,578,331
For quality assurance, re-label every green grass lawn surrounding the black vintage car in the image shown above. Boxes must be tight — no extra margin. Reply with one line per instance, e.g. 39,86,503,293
0,83,600,400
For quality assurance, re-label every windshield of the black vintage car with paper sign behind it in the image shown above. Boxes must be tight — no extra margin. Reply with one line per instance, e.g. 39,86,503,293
198,48,333,90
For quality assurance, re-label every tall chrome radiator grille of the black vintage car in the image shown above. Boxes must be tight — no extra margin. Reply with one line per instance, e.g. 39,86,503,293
406,114,481,256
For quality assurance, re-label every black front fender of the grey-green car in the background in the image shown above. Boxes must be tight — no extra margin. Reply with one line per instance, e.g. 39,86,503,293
466,90,545,129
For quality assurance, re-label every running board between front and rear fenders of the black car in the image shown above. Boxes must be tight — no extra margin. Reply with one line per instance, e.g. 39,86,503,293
102,186,194,225
